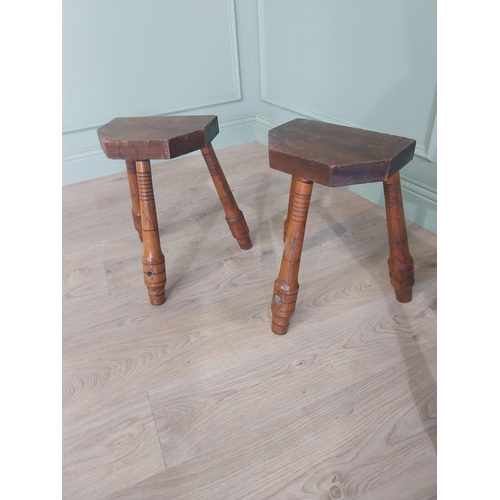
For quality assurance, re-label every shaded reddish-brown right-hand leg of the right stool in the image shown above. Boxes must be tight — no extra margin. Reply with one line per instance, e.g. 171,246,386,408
384,172,415,302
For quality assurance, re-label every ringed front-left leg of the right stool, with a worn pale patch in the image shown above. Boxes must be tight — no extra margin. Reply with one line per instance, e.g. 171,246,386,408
271,179,313,335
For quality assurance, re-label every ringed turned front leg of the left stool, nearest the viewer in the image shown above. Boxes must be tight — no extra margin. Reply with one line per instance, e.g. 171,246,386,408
136,160,167,306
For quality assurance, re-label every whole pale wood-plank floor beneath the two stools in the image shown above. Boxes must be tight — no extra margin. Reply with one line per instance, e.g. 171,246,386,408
62,143,437,500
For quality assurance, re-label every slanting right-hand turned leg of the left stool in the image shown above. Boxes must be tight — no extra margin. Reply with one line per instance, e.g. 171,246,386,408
201,144,252,250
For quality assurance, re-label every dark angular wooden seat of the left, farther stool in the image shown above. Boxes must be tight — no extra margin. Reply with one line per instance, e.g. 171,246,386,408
97,115,219,160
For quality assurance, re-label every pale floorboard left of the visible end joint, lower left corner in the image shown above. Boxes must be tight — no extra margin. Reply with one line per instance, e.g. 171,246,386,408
62,393,165,499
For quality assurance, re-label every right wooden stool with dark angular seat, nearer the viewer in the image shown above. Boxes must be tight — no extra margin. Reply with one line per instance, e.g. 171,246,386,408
269,119,416,335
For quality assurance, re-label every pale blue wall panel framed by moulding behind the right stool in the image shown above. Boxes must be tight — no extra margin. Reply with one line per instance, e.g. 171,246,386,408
258,0,436,161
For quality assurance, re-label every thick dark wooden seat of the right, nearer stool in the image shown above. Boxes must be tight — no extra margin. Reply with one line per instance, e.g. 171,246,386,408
269,118,416,187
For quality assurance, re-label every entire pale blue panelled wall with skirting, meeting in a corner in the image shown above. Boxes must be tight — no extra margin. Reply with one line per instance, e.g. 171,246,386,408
63,0,437,232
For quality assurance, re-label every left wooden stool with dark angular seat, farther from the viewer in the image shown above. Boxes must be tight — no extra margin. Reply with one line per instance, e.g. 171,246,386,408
97,116,252,305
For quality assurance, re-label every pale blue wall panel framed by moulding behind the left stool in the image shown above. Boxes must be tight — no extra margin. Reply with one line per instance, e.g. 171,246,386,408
63,0,241,132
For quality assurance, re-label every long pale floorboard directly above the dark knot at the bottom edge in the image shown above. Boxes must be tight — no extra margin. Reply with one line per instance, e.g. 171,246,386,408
100,346,435,499
